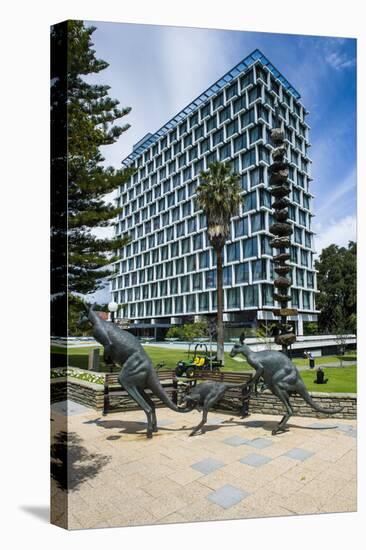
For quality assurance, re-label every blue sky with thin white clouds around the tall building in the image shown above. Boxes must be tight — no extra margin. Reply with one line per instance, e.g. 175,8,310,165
85,22,356,258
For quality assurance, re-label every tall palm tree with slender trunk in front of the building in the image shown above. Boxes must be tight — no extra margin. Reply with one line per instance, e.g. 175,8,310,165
196,162,242,363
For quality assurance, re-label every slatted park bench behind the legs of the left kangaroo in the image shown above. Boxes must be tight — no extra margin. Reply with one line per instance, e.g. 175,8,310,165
103,370,176,415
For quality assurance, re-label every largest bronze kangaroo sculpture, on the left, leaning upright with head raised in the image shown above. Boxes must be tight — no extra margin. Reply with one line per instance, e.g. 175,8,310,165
79,306,192,438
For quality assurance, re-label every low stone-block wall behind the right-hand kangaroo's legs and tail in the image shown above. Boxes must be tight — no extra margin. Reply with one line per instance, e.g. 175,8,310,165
249,390,357,418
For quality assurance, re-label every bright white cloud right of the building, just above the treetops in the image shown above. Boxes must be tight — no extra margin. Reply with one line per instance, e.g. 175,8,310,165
315,216,357,254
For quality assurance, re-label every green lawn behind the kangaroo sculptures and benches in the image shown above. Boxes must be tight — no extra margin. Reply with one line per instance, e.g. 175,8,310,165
52,345,357,393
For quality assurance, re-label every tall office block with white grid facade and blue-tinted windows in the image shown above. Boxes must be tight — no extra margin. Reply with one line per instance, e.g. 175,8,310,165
111,50,316,336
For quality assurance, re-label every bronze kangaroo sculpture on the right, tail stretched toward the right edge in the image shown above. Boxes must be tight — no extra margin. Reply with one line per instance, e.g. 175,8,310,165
230,334,343,435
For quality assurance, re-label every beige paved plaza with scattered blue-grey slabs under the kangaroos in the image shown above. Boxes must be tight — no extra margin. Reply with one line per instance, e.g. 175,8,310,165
52,402,357,529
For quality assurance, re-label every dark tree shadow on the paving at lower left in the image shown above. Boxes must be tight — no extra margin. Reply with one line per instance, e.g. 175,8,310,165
51,431,110,491
